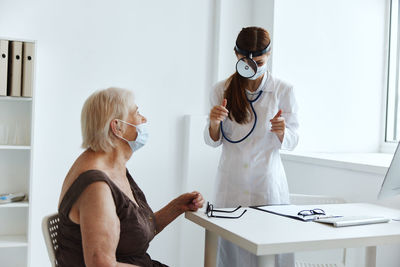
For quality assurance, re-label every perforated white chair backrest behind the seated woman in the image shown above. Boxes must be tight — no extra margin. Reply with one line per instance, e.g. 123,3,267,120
42,213,60,267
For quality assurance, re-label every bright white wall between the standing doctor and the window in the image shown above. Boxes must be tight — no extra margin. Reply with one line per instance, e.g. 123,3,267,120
272,0,389,152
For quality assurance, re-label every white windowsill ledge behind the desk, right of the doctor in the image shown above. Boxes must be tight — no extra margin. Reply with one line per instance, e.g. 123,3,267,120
280,150,393,175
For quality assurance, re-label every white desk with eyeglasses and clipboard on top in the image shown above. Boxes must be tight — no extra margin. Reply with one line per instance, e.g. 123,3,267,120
185,203,400,267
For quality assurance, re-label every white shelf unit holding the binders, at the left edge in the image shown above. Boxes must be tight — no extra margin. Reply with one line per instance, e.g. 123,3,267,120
0,38,36,267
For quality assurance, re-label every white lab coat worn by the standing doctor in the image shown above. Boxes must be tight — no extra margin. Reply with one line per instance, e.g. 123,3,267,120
204,72,298,267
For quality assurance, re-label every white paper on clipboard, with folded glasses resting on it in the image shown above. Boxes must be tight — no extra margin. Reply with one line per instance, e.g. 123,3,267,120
251,205,341,222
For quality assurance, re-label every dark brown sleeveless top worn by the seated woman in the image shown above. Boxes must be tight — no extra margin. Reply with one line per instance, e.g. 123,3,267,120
56,170,166,267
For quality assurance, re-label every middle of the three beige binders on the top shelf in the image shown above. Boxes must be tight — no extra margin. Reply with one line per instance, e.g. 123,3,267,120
7,41,22,96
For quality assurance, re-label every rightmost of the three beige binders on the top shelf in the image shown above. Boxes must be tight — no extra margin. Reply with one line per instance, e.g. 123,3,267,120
22,42,35,97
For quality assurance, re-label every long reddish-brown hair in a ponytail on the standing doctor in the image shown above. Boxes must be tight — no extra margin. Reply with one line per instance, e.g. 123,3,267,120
224,27,271,124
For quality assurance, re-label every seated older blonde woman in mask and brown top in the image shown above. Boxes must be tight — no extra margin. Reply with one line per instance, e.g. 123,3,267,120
56,88,204,267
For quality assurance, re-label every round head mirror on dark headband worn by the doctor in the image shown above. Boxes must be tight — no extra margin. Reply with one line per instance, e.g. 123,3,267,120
235,42,271,78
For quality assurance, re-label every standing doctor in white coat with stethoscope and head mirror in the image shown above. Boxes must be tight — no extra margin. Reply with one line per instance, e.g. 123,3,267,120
204,27,298,267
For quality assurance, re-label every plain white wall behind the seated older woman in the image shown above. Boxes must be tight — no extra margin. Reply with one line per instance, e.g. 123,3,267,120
0,0,216,266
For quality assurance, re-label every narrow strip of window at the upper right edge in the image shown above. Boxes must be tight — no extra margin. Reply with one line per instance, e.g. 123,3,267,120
385,0,400,143
